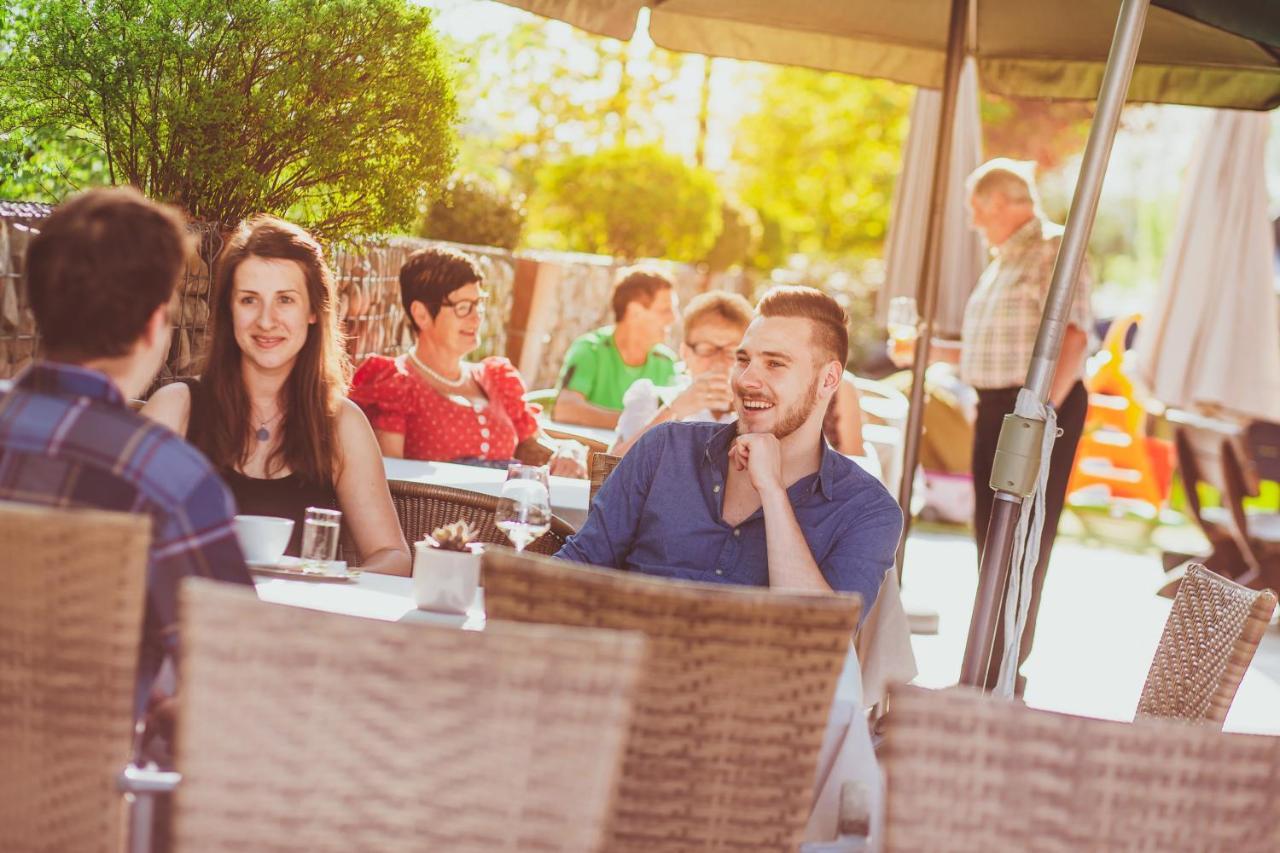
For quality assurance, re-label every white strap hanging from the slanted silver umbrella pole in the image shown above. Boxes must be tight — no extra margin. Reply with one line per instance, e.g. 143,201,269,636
996,388,1059,697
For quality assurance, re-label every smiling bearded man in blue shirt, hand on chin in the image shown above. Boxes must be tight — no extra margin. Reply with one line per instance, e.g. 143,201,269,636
557,287,902,613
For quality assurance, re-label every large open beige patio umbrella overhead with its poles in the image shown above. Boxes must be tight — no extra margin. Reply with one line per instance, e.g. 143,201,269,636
504,0,1280,685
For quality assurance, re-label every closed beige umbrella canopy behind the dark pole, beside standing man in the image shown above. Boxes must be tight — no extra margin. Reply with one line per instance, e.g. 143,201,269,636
876,60,987,337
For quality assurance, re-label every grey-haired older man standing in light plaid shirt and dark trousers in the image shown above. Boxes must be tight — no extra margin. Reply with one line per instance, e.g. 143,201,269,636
960,159,1092,695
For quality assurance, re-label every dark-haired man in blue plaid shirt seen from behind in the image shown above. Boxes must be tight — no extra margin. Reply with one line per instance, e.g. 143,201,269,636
0,190,252,716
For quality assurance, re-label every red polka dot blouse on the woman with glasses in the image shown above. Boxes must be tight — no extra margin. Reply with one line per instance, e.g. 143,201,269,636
351,356,539,462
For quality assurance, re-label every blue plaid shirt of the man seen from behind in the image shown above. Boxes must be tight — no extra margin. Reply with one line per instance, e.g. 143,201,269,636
0,362,253,712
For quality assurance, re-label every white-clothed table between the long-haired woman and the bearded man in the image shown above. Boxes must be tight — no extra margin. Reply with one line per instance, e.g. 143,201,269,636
253,563,883,849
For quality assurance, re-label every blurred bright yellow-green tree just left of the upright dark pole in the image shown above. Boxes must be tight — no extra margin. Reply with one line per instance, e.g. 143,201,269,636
733,68,913,265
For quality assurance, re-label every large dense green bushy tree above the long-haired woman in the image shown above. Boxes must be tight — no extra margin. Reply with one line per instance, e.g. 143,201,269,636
0,0,456,232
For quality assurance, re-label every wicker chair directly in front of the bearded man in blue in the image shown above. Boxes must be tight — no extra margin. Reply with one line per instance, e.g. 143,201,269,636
481,548,860,853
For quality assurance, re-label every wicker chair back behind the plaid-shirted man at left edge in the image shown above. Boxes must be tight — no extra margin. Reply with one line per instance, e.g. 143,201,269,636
0,503,151,852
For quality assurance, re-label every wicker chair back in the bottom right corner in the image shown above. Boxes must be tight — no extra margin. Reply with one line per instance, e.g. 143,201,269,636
879,686,1280,853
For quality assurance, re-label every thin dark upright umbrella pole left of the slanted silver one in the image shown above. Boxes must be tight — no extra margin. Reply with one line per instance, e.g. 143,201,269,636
897,0,970,583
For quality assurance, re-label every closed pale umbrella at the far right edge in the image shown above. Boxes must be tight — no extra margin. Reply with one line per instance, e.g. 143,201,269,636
1137,109,1280,421
